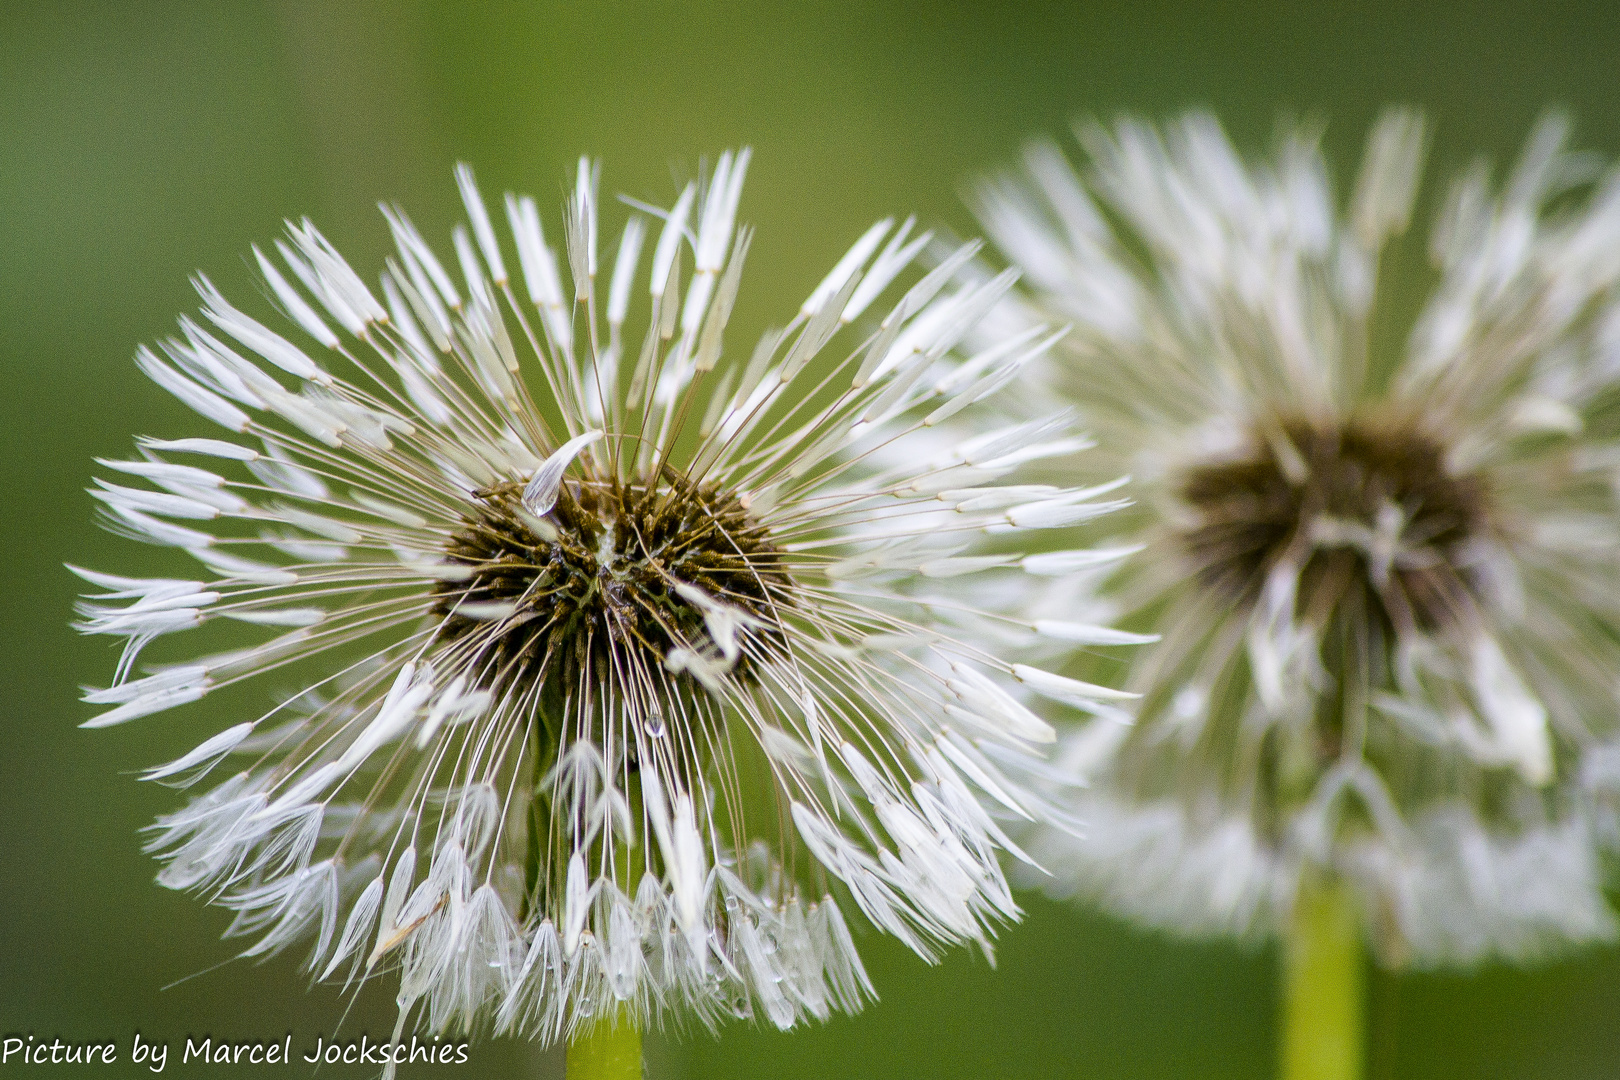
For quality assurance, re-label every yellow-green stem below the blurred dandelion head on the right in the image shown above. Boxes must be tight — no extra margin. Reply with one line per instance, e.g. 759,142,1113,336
1280,881,1366,1080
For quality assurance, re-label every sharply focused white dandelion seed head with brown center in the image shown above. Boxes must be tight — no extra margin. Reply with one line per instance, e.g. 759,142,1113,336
75,151,1127,1041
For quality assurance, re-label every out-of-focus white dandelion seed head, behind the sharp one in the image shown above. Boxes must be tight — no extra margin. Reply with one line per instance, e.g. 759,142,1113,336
977,110,1620,965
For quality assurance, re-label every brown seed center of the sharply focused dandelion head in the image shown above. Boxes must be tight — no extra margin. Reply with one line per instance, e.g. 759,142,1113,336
434,479,792,687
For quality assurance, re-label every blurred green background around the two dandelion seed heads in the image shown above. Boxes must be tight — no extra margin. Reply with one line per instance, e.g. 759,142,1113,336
9,0,1620,1080
